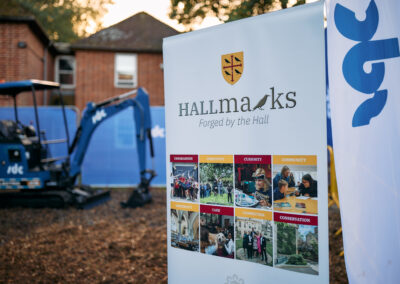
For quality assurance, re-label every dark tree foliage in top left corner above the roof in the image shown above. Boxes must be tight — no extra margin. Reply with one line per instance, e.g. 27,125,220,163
0,0,113,42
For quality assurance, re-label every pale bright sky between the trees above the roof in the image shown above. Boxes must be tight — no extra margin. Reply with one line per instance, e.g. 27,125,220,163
103,0,317,32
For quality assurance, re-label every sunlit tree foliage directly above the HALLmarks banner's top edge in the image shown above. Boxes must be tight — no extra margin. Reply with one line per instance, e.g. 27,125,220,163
169,0,305,30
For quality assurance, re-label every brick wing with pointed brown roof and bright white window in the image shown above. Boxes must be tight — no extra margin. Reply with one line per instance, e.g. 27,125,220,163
71,12,178,110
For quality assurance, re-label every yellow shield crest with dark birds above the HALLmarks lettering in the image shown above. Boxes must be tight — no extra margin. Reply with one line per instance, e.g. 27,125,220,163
221,51,243,85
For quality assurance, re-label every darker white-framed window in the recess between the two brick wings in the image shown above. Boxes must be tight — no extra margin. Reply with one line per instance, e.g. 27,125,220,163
56,56,75,88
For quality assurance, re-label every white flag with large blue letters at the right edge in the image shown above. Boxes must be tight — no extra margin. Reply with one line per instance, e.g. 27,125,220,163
328,0,400,284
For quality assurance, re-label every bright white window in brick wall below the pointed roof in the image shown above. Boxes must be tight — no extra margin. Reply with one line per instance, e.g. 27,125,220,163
114,54,137,88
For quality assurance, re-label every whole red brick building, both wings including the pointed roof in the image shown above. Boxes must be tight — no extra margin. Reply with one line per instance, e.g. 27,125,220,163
0,12,178,111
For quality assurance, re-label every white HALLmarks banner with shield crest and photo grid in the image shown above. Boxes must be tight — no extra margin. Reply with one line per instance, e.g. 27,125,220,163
163,2,329,284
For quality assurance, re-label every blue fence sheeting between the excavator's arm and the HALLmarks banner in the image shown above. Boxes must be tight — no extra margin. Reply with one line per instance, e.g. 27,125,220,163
82,107,166,186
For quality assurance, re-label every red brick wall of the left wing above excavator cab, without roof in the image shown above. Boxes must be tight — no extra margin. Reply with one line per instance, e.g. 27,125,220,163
0,23,54,106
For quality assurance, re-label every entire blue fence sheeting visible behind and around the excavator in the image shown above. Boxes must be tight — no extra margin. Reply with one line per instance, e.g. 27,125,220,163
0,107,166,186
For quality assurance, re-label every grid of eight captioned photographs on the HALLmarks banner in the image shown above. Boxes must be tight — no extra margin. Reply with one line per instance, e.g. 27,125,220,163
167,155,319,275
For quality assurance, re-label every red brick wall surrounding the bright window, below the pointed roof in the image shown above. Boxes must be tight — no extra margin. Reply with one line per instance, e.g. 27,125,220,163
75,50,164,111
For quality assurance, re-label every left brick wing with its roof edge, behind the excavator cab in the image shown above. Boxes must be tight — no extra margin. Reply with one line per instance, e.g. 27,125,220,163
0,16,56,106
